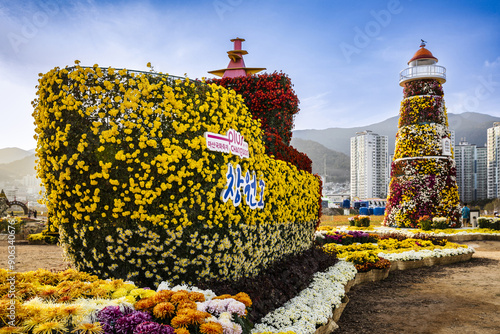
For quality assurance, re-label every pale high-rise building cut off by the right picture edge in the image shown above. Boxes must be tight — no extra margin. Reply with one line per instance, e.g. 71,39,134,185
486,122,500,198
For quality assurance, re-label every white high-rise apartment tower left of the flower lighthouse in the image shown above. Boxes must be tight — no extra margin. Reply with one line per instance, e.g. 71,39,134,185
351,130,388,199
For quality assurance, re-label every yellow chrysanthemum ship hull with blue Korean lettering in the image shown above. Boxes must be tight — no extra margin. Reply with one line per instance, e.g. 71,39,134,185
33,63,320,286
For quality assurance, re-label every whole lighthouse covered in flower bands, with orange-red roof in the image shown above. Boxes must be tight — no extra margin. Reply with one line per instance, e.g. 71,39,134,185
384,40,459,227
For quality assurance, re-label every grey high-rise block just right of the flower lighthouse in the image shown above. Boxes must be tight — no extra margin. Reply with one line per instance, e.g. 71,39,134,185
455,140,486,203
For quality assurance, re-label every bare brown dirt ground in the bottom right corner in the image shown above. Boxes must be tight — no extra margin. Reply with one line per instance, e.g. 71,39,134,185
335,241,500,334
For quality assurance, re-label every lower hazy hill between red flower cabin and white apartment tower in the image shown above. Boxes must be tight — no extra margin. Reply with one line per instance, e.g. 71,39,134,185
291,138,351,183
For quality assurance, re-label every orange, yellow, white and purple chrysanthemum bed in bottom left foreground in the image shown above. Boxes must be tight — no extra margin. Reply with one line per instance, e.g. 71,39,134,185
0,269,252,334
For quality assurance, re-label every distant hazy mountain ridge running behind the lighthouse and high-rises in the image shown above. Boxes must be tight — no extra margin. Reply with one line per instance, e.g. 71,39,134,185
293,112,500,155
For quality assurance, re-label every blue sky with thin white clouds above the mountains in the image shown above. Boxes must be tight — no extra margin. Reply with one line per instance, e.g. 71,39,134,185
0,0,500,149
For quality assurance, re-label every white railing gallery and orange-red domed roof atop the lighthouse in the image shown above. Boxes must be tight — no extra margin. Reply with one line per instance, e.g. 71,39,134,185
399,40,446,86
